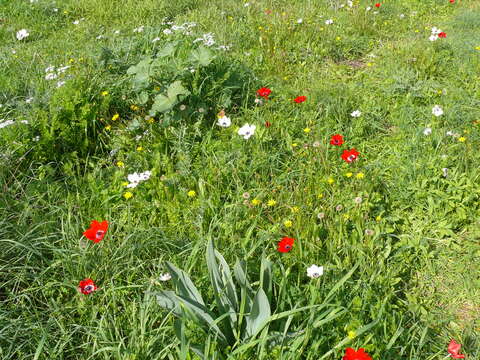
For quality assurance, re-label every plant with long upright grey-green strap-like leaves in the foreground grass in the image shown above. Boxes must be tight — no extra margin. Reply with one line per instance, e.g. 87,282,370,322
156,241,316,358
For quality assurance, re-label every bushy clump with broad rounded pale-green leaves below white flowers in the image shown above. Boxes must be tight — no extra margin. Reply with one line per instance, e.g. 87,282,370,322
127,40,255,126
